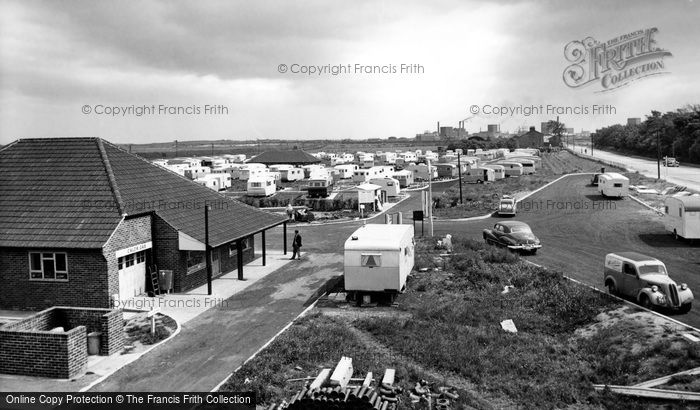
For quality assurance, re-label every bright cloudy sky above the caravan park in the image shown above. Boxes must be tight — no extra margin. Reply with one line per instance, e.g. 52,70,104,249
0,0,700,144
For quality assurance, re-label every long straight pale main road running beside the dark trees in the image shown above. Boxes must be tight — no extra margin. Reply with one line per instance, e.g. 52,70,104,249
572,146,700,192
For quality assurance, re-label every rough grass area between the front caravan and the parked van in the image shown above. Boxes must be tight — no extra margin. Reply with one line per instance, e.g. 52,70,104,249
223,237,700,409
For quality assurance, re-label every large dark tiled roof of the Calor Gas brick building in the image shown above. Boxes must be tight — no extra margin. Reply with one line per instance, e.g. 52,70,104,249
0,138,286,248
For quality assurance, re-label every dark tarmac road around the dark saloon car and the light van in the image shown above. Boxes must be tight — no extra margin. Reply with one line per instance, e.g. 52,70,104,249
435,175,700,327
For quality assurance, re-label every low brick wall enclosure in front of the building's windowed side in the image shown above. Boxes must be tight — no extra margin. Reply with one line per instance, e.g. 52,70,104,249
0,307,124,379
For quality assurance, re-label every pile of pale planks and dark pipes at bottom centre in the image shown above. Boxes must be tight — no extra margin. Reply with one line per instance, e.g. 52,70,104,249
268,356,401,410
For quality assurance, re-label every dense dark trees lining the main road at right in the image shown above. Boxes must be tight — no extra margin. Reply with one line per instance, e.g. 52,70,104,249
591,104,700,163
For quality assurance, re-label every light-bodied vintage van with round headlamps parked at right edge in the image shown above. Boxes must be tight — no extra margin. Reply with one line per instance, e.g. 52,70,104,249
603,252,693,313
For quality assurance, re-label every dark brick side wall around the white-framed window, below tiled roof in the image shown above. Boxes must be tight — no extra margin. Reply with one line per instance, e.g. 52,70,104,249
0,248,109,310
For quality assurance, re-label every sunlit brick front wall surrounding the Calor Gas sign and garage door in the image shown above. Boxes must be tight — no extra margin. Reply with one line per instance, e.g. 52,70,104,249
102,215,153,299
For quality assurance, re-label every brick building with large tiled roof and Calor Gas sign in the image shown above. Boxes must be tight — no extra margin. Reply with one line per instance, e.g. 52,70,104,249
0,138,286,309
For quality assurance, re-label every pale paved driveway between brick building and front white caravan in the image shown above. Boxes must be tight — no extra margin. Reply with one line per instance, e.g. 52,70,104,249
90,253,343,392
